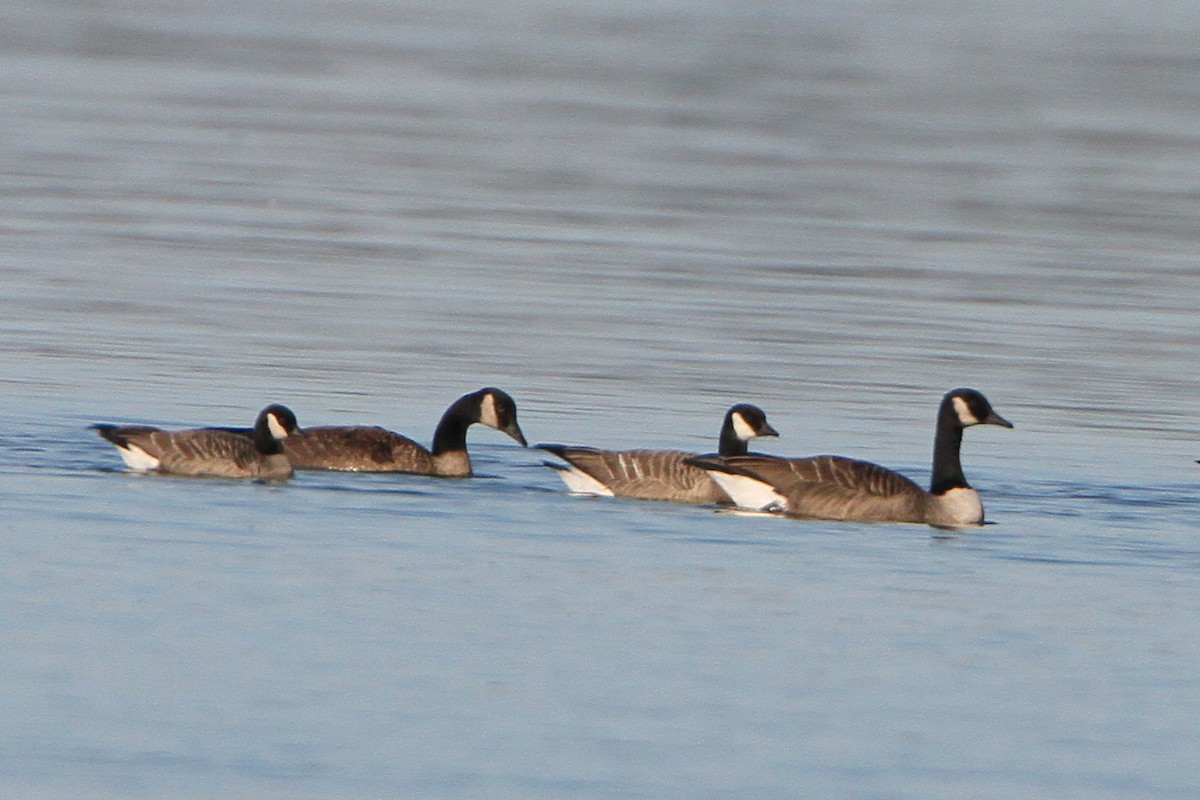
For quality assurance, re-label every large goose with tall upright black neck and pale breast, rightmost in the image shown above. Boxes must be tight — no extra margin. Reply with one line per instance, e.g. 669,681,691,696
688,389,1013,527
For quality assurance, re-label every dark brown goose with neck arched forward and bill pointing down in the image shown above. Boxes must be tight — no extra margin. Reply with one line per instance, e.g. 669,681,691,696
284,387,528,477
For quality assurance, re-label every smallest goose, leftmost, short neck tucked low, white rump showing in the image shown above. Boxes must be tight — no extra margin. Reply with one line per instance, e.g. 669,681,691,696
91,405,296,480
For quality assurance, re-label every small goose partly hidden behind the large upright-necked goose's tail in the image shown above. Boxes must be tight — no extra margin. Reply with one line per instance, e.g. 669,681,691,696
538,403,779,503
